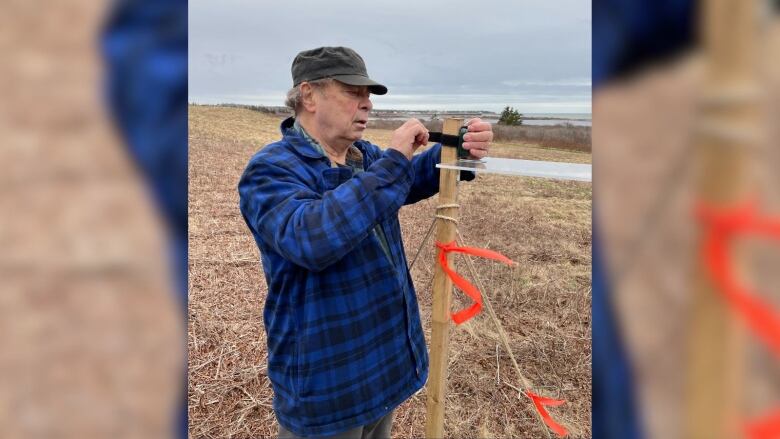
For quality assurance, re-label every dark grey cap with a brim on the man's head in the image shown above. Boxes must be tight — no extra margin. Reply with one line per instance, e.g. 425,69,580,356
292,47,387,95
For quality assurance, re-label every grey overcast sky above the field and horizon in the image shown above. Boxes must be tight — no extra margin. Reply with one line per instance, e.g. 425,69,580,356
189,0,591,113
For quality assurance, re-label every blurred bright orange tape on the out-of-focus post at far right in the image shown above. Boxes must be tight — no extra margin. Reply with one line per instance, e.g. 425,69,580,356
698,203,780,439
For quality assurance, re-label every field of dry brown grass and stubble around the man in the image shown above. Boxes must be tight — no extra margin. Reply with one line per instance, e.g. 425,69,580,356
188,106,591,438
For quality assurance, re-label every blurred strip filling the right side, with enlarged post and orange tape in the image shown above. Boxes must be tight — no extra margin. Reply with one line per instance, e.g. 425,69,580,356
593,0,780,438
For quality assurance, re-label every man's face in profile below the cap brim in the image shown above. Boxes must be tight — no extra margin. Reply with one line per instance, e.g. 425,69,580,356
313,81,373,142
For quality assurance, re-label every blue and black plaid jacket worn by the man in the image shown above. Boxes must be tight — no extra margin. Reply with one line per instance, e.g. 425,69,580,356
238,118,474,436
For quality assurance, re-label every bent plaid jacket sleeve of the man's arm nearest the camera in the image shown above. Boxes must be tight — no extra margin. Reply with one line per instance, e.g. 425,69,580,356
238,150,414,271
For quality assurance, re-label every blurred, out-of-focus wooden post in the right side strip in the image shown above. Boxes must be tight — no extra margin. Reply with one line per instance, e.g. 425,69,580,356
682,0,758,439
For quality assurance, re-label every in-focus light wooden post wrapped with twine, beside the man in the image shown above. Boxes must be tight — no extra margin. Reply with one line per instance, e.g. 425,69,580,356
425,119,463,438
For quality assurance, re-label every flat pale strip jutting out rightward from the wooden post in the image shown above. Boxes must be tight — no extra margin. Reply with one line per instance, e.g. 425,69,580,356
436,157,591,181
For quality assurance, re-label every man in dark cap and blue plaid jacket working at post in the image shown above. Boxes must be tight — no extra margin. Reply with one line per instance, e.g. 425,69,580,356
238,47,493,438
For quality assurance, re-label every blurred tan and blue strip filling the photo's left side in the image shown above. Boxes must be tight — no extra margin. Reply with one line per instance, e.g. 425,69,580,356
0,0,187,438
